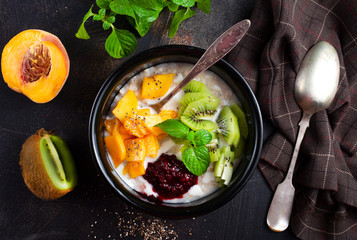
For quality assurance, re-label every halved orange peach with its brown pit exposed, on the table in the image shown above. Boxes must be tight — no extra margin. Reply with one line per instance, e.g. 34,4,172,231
1,29,70,103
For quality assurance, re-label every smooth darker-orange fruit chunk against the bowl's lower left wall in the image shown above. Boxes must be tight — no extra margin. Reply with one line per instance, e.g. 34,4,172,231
104,132,126,167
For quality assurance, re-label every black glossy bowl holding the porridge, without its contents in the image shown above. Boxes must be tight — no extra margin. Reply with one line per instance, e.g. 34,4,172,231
89,45,263,217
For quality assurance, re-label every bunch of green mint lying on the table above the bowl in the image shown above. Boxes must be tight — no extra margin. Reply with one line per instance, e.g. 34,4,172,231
76,0,211,58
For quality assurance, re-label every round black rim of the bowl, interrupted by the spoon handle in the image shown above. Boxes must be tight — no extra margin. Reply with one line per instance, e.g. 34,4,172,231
88,45,263,218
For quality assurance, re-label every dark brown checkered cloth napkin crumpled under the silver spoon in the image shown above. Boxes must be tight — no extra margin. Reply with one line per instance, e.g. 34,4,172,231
229,0,357,239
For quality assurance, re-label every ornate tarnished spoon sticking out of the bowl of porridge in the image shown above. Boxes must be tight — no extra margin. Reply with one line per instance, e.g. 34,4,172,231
150,19,250,112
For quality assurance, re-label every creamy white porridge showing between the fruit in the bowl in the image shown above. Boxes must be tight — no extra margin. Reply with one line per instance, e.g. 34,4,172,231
105,63,238,203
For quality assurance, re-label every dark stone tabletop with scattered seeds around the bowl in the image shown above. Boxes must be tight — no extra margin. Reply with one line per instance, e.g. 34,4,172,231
0,0,295,240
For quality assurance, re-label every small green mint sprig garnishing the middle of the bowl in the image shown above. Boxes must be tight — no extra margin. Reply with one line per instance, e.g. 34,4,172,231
155,119,212,176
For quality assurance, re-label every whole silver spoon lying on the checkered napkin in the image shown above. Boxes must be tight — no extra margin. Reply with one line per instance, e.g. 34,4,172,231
267,42,340,232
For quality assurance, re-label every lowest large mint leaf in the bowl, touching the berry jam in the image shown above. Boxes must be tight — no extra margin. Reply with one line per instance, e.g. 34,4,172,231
182,146,210,176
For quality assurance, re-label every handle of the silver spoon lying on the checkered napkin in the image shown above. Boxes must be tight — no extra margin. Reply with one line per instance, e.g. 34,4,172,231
267,112,312,232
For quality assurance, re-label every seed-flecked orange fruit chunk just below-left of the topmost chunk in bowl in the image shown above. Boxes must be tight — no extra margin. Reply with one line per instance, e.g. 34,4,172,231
113,90,138,122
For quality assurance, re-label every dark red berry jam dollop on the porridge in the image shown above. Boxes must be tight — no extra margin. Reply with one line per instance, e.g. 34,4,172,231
144,154,198,200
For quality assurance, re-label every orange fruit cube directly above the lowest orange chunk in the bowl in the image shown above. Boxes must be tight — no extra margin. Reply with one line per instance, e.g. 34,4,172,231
124,138,146,162
